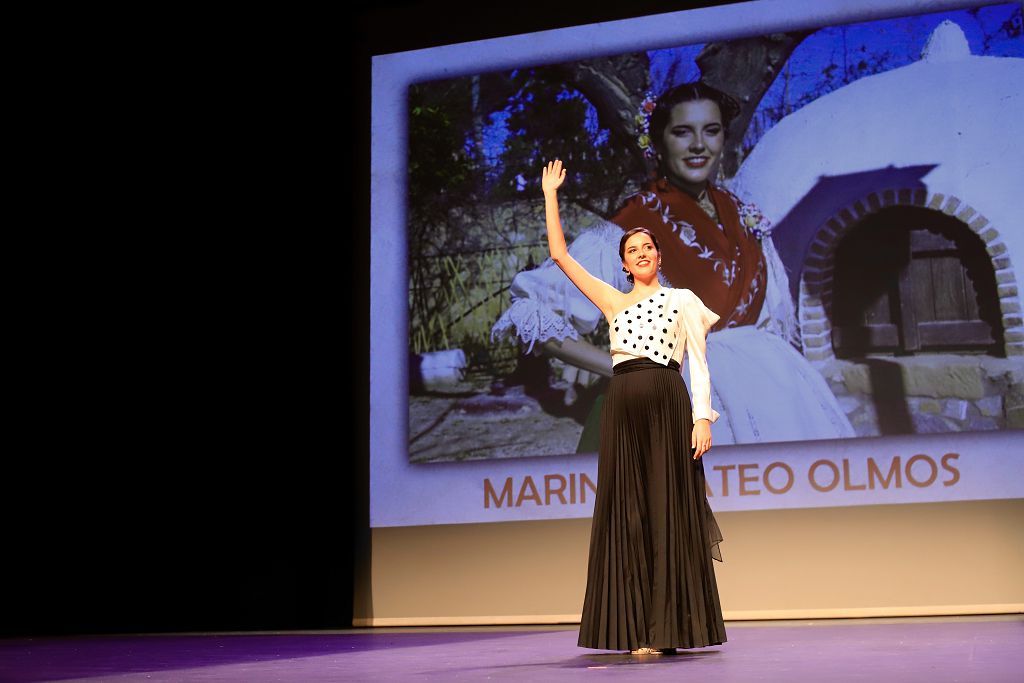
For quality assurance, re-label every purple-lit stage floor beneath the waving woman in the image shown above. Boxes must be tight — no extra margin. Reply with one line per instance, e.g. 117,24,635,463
0,614,1024,683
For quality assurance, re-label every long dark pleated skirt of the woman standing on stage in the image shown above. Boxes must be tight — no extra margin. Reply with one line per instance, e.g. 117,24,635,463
579,358,726,650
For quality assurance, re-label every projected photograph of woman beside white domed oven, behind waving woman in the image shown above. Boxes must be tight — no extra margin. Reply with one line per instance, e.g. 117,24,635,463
406,3,1024,463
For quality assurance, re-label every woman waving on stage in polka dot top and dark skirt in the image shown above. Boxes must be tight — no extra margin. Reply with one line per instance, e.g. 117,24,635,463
542,160,726,654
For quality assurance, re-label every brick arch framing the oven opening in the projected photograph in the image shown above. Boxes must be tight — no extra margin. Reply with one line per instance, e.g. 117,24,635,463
797,187,1024,366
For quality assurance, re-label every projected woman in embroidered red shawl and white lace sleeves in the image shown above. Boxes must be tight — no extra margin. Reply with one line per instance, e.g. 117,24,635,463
492,82,855,444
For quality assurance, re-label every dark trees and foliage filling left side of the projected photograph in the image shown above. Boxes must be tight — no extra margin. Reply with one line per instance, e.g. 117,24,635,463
408,71,637,368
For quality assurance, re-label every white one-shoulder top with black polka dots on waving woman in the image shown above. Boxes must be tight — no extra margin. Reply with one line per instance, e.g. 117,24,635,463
608,287,719,422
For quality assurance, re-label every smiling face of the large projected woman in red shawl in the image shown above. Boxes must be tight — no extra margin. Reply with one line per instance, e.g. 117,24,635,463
662,99,725,195
